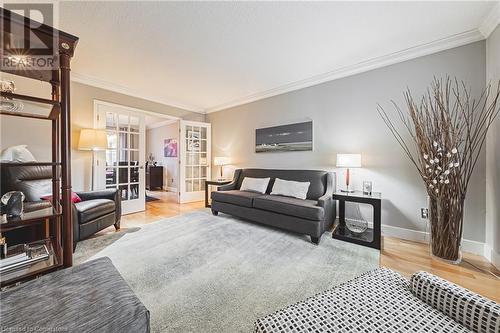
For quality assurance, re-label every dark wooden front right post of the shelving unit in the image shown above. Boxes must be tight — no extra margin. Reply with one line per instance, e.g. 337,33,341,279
60,53,73,267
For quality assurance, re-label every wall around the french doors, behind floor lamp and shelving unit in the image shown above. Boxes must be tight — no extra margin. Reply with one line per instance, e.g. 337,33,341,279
0,73,205,191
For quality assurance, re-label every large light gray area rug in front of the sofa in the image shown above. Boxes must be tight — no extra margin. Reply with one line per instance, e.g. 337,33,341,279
77,210,379,332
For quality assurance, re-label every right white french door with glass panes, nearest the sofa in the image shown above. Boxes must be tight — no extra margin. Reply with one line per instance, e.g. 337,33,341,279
179,120,212,203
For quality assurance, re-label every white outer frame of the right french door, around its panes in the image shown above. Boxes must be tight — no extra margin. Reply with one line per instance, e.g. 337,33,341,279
178,120,212,203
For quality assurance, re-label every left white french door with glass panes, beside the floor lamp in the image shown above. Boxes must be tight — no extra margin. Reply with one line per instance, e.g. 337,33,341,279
94,101,146,214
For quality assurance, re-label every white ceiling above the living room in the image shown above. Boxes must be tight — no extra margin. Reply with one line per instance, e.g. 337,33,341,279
60,2,500,112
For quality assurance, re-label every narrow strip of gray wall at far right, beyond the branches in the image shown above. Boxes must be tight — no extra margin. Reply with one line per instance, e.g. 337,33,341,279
486,25,500,260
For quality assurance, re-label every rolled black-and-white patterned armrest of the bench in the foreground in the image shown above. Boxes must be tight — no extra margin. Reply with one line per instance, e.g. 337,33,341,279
410,271,500,333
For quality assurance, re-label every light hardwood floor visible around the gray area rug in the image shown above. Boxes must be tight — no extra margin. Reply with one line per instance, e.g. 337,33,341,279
114,192,500,303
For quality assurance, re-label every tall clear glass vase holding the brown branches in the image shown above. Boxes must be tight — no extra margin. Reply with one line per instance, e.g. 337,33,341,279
429,193,464,264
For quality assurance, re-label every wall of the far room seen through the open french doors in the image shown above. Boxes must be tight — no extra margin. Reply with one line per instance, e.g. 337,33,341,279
146,121,179,188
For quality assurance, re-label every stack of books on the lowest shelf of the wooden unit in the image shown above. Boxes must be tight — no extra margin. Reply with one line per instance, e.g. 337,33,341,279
0,244,49,273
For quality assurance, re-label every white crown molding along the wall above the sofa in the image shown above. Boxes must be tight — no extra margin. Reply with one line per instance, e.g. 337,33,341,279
206,29,484,113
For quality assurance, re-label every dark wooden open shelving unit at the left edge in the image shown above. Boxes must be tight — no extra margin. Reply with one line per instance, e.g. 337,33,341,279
0,8,78,287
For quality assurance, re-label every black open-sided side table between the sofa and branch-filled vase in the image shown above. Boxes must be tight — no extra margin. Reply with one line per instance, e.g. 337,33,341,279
332,191,382,250
